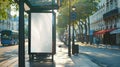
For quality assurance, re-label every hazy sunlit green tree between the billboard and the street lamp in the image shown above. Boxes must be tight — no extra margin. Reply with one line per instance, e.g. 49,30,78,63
57,4,69,36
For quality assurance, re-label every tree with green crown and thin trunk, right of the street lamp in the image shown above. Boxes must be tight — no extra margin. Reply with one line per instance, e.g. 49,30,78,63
74,0,98,41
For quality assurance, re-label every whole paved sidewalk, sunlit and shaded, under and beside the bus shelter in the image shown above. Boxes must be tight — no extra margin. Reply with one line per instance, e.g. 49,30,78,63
10,42,99,67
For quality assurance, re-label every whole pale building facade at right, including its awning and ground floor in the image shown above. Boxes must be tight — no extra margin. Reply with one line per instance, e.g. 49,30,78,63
90,0,120,45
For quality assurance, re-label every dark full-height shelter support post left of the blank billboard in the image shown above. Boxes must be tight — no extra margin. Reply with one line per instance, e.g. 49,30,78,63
19,0,25,67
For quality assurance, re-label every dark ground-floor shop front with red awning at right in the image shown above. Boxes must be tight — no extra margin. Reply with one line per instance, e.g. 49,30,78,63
94,29,116,45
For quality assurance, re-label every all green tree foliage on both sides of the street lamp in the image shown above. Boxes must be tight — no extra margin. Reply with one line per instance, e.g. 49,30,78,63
57,0,99,37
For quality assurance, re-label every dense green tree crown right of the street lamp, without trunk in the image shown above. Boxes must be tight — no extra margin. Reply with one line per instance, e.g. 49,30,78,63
75,0,97,21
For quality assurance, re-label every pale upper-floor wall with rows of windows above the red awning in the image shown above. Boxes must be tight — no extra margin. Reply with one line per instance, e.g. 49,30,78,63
90,0,120,30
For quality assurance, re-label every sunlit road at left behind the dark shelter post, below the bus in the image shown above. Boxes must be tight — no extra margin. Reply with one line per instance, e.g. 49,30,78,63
0,42,27,67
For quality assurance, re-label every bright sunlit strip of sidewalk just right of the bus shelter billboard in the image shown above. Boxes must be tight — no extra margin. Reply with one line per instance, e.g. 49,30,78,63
54,42,75,67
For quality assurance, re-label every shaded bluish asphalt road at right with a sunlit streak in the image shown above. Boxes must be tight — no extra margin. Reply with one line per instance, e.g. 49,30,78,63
79,46,120,67
